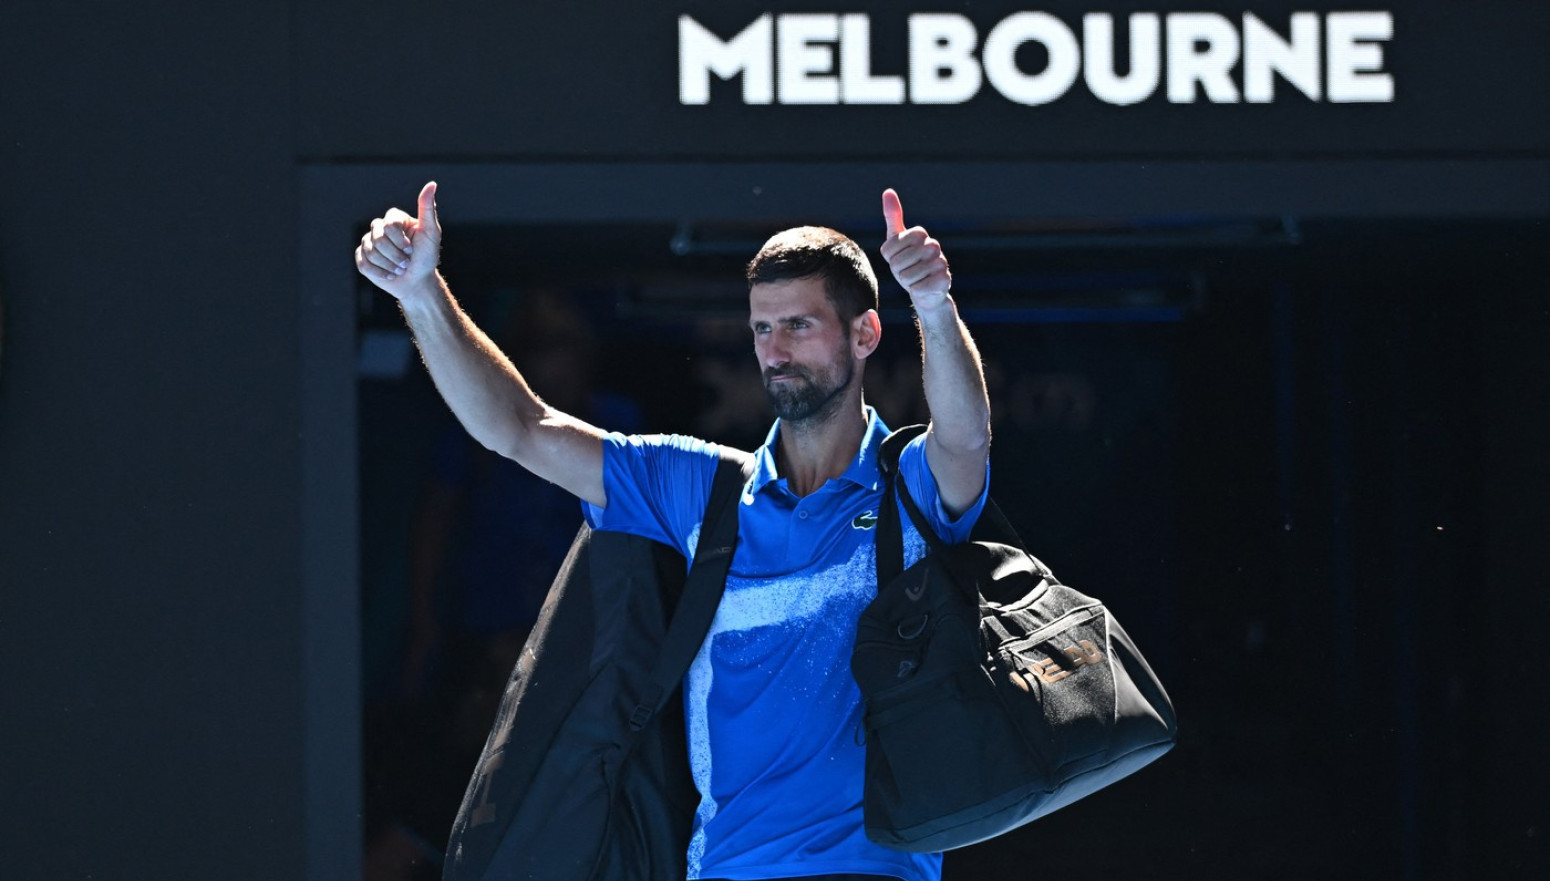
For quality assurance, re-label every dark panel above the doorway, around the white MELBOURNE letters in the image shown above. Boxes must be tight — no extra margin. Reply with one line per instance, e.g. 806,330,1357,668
296,0,1550,160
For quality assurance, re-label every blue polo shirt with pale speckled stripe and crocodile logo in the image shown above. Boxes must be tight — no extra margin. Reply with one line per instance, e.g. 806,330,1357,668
583,408,989,881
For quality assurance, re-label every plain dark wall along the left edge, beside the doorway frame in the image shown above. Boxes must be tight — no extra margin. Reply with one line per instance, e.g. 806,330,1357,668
0,3,305,879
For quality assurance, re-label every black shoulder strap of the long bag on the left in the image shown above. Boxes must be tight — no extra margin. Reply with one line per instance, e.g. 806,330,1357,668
629,447,753,731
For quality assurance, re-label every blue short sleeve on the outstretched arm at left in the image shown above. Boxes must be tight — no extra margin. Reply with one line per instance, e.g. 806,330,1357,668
581,433,721,557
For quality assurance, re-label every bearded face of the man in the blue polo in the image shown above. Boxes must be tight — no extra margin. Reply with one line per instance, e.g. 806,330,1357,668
749,278,856,422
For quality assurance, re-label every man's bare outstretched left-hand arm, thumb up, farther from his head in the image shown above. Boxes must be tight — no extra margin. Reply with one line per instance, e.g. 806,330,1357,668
355,183,608,507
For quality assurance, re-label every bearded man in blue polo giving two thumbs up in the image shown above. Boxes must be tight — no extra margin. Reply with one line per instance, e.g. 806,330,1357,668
355,183,990,881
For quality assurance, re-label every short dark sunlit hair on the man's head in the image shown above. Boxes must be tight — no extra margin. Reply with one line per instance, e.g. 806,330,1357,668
747,226,877,327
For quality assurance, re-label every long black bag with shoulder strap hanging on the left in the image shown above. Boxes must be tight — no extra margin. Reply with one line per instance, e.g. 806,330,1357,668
442,450,749,881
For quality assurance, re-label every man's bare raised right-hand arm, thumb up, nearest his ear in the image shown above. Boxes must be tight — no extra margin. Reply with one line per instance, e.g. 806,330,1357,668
882,189,990,517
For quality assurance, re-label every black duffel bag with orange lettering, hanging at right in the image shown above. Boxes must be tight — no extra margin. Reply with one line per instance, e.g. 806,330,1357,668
851,427,1176,853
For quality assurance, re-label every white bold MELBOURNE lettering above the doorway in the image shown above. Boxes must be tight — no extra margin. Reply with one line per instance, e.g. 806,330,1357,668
677,11,1395,105
